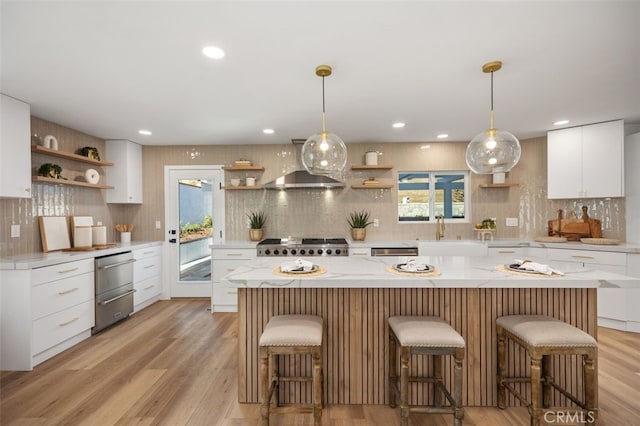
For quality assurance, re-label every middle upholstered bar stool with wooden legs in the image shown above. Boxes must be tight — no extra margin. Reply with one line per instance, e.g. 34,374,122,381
389,316,465,426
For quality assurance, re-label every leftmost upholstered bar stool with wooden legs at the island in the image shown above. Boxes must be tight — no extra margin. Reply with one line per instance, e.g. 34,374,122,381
260,315,324,426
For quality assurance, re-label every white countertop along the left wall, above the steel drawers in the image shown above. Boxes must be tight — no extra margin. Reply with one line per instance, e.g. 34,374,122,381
0,241,162,270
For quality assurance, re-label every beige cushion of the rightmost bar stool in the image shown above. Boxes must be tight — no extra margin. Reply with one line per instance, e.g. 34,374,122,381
496,315,598,348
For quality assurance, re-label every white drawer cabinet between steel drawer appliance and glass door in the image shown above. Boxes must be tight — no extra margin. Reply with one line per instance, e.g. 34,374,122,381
132,246,162,312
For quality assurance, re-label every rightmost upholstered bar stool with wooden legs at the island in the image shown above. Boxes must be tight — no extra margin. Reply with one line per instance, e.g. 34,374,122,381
496,315,598,426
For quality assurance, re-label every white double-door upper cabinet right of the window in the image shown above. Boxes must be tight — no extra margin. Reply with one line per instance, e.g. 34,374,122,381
547,120,624,199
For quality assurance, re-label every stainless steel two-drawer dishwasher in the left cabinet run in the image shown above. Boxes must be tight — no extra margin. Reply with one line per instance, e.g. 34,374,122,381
91,251,135,334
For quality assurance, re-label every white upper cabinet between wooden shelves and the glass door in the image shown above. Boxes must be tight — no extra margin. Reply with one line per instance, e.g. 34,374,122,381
105,140,142,204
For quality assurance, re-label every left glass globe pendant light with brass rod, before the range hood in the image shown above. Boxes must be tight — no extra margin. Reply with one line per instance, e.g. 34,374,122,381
302,65,347,177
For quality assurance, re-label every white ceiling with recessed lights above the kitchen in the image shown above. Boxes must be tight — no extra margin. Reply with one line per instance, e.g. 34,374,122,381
0,0,640,145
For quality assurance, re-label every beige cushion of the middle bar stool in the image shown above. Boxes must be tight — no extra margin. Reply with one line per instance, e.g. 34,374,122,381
389,316,465,348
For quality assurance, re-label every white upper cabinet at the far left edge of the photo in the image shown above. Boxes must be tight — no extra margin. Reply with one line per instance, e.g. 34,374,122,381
0,94,31,198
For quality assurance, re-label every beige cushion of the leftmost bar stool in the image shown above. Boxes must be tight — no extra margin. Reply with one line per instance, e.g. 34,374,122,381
260,315,322,346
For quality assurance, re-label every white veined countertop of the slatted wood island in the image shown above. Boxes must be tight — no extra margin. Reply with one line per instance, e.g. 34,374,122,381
222,256,640,288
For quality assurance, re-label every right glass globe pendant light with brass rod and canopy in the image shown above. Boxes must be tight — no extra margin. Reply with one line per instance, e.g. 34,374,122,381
466,61,521,174
